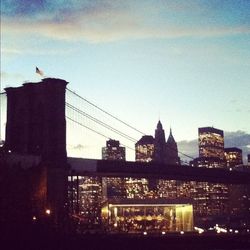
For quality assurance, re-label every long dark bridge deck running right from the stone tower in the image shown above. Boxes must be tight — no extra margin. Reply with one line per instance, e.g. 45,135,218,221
68,157,250,184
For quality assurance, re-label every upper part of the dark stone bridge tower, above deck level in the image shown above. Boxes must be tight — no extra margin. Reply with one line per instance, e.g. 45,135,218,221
5,78,67,163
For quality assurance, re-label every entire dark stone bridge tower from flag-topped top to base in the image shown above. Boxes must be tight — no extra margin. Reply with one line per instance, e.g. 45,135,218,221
4,78,67,228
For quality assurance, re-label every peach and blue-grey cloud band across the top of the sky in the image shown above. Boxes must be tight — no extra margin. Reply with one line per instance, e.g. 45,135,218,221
2,1,250,43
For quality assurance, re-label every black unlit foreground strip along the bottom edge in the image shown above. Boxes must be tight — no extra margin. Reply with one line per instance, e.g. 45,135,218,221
0,228,250,250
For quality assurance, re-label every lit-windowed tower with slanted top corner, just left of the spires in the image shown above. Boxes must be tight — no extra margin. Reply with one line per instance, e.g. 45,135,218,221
135,135,154,162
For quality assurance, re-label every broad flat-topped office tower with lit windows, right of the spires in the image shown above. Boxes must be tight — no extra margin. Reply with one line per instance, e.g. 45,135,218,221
199,127,224,160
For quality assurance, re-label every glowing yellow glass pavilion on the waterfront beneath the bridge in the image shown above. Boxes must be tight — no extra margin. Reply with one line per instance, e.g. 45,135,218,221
102,199,193,233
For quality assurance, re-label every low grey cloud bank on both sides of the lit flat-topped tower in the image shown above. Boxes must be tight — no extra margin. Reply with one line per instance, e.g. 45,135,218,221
178,130,250,164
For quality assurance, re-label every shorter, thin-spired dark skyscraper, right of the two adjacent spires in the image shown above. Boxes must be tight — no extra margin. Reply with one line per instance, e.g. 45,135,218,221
166,129,180,165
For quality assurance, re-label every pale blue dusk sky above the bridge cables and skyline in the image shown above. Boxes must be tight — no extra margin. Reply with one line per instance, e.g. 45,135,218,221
1,0,250,160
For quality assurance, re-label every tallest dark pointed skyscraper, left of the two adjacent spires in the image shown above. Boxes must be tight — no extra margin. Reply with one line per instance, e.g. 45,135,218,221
154,121,167,163
